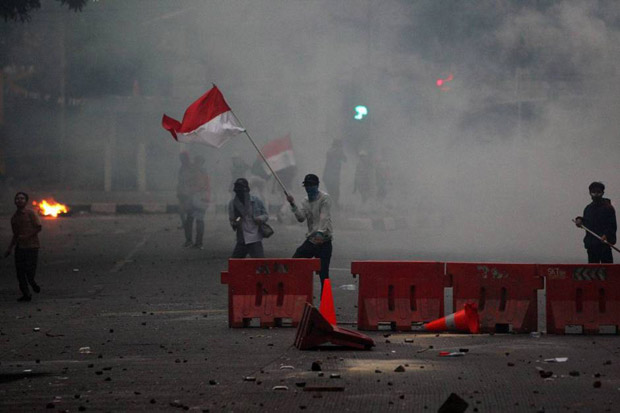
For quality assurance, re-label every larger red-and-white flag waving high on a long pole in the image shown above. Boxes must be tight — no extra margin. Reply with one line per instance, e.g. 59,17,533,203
161,86,245,148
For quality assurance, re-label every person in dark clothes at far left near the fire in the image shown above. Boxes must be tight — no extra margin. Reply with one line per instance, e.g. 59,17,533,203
4,192,41,301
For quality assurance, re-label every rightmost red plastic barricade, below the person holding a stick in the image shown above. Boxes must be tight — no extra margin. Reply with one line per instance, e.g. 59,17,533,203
538,264,620,334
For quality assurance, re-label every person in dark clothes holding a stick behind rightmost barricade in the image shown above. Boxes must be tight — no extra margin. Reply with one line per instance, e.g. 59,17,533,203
574,182,617,264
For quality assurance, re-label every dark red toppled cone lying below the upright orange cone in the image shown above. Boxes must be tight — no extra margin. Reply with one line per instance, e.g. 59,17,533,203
295,303,375,350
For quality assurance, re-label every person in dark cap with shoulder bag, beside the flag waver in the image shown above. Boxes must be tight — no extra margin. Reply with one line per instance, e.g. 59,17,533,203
228,178,269,258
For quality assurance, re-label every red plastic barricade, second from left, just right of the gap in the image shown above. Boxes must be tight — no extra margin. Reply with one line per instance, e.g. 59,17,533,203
351,261,448,331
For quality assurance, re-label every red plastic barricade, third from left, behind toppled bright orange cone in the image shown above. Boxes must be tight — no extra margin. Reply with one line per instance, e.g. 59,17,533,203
446,262,543,332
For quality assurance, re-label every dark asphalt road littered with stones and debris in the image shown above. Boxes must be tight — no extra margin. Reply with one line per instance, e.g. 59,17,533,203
0,211,620,412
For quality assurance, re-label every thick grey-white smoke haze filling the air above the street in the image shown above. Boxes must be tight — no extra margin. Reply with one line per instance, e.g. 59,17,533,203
2,0,620,262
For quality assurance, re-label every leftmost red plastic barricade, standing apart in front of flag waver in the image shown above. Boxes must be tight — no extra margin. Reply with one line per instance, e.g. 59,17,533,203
222,258,321,327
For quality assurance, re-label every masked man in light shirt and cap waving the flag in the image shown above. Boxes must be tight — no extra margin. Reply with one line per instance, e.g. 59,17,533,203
286,174,333,288
